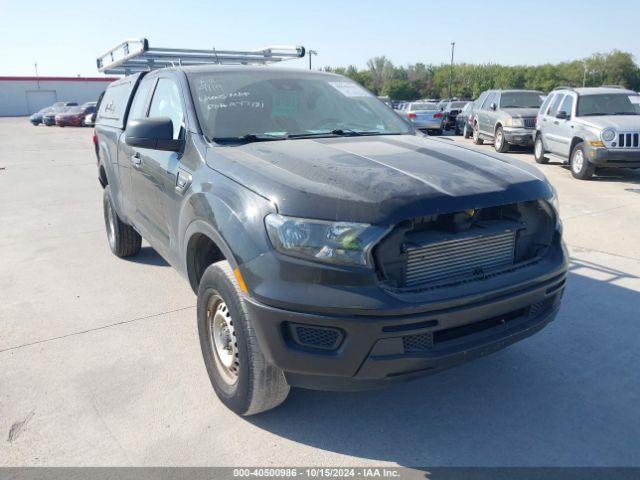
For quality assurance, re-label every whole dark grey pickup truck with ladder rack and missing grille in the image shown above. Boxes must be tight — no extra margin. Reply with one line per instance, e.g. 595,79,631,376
95,40,568,415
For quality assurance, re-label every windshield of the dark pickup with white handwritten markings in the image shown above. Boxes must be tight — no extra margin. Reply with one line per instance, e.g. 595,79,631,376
189,68,411,141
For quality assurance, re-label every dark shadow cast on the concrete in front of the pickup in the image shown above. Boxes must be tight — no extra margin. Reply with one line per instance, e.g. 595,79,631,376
247,255,640,466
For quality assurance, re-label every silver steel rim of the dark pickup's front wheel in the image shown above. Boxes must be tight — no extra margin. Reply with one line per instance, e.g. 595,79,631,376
207,295,240,385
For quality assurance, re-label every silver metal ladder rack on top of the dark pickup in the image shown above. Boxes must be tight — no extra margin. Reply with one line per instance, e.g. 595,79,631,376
96,38,305,75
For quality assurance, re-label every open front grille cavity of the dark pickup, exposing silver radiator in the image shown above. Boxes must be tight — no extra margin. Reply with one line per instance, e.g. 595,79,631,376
374,201,555,291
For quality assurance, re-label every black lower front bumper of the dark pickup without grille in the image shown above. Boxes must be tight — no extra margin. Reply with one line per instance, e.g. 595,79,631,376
246,266,566,390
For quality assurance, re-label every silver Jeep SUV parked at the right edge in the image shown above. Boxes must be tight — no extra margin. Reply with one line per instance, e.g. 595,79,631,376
533,87,640,180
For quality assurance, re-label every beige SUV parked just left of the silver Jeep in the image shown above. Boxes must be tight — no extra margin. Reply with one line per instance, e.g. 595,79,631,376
473,90,544,153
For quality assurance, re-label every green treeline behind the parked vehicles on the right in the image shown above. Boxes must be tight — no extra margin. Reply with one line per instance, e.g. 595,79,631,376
325,50,640,100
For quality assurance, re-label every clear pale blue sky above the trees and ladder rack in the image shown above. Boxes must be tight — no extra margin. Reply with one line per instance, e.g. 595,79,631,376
0,0,640,75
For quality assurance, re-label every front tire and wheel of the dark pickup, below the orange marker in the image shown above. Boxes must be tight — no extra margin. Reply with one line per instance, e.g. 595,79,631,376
197,260,290,416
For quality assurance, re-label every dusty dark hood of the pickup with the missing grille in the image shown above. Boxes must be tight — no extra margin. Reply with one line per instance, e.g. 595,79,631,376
207,135,551,225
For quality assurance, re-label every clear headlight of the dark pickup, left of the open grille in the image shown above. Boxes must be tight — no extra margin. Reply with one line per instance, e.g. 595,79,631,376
265,213,387,267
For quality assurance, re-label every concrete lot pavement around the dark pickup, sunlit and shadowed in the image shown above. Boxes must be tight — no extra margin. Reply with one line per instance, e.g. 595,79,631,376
0,118,640,466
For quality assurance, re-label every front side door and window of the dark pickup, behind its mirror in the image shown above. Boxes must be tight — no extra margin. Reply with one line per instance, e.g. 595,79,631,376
131,77,186,258
